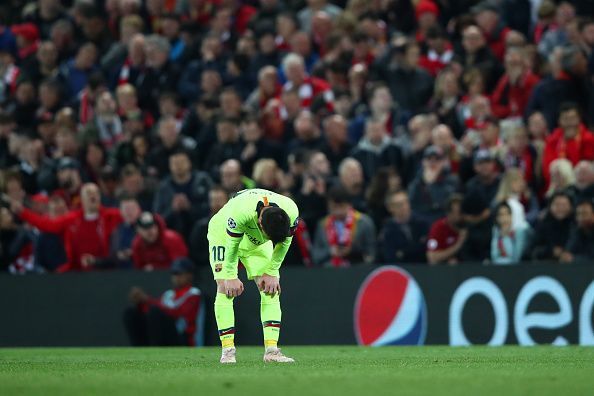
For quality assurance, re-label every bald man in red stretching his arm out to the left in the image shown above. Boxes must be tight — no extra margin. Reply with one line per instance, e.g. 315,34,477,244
11,183,122,272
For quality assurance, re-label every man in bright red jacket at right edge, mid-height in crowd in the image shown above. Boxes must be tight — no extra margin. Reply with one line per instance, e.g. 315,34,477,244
542,102,594,184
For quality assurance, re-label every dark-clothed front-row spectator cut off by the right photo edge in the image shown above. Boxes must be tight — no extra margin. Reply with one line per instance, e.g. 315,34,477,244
561,199,594,263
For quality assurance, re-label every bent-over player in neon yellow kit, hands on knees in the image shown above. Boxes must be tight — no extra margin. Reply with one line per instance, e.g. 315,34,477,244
208,189,299,363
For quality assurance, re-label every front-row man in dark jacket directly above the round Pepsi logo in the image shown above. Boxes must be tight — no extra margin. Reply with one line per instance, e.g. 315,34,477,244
379,190,429,263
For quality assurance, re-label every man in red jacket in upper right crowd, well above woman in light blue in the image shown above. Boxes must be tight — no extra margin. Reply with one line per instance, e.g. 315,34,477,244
491,47,539,118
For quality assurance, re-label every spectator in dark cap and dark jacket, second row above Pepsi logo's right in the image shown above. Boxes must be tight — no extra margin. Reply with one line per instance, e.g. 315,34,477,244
408,145,459,223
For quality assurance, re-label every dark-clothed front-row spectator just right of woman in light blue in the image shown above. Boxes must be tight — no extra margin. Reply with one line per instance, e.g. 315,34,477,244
532,192,574,261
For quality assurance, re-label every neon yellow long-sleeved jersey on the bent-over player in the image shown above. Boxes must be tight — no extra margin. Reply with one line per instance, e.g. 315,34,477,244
217,188,299,277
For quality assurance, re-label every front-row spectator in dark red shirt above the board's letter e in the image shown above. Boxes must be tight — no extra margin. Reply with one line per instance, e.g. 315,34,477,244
427,194,467,265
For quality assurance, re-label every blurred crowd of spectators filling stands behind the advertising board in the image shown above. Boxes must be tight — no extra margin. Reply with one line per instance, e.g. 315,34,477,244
0,0,594,273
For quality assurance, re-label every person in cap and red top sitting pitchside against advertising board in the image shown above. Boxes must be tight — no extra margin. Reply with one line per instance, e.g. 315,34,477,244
124,258,204,346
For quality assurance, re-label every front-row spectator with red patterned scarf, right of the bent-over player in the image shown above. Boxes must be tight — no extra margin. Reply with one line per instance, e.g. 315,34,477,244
312,187,376,268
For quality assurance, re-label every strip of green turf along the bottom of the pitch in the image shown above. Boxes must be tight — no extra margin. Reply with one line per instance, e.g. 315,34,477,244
0,347,594,396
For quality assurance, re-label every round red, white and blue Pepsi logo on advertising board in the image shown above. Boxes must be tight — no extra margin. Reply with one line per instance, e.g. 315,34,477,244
354,266,427,346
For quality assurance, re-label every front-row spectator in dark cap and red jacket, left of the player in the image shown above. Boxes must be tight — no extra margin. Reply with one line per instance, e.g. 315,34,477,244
132,212,188,271
